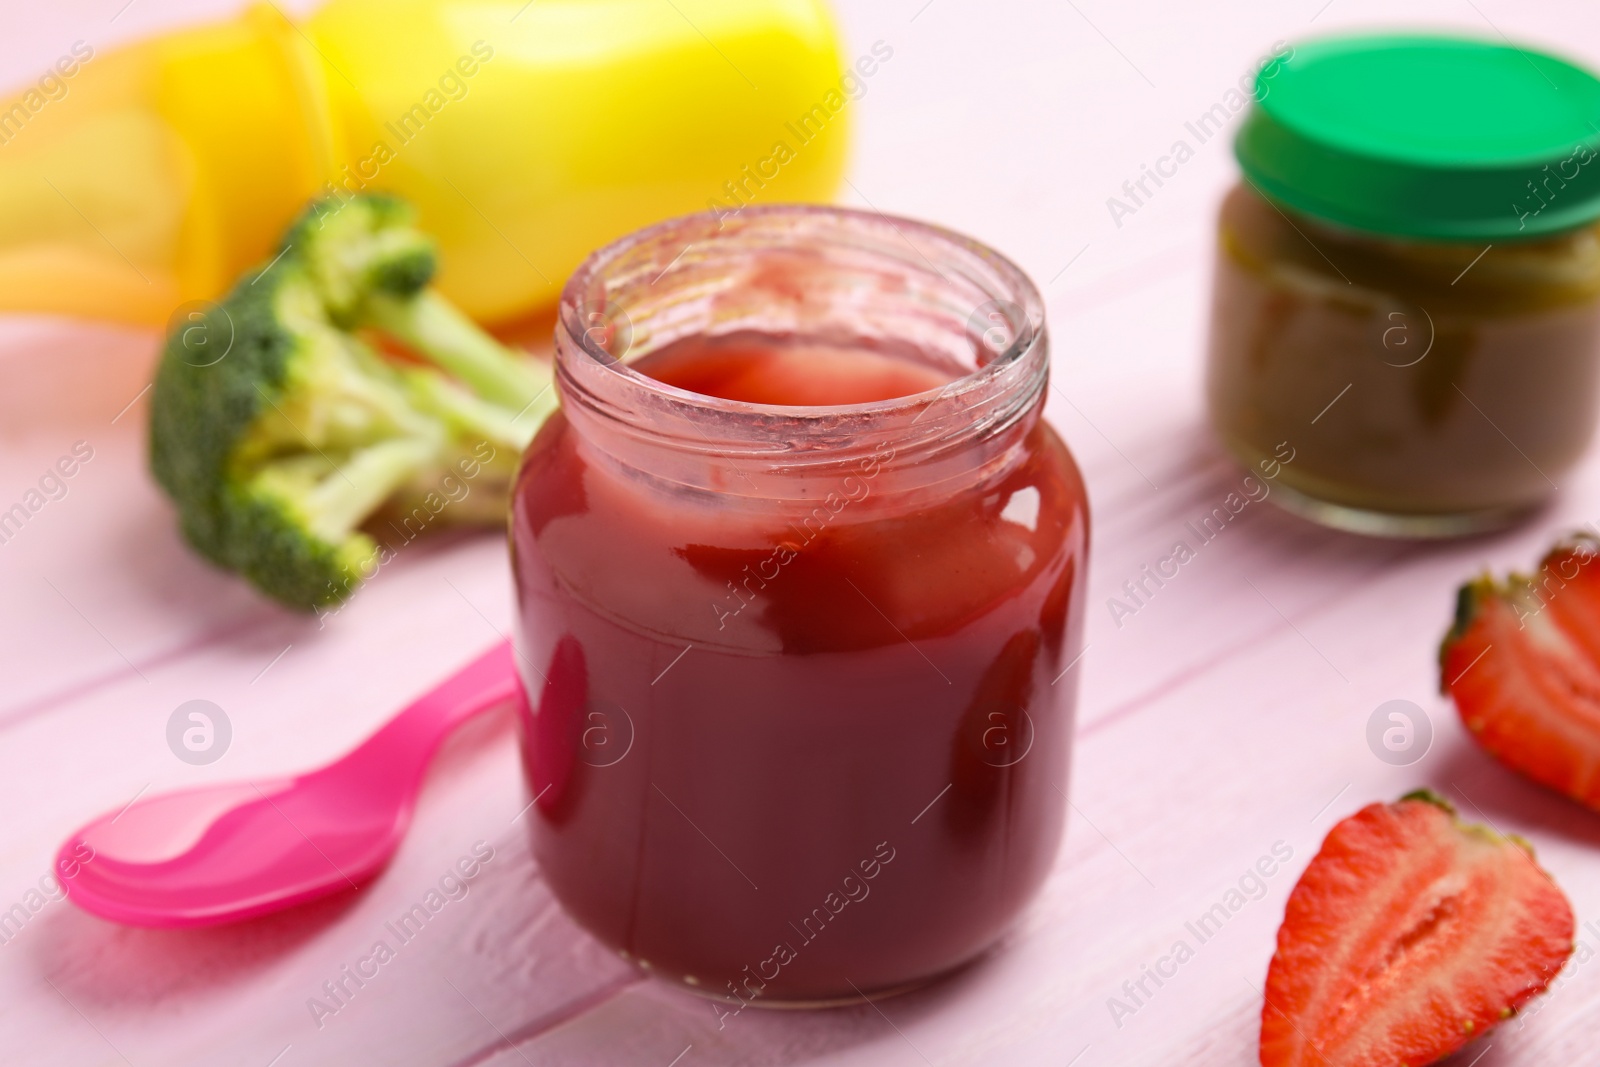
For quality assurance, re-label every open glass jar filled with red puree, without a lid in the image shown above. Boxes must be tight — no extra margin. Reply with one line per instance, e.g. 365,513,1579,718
512,206,1088,1013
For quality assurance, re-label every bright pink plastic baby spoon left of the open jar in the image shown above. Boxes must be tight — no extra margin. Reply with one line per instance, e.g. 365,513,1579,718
58,643,520,926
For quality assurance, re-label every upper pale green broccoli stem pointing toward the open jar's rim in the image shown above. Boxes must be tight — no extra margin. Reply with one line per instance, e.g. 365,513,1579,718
366,290,554,412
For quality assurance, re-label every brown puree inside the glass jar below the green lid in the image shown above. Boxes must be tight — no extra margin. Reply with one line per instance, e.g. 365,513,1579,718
1206,184,1600,534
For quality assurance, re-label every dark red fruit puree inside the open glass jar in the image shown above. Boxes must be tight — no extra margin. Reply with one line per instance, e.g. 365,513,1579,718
512,323,1088,1019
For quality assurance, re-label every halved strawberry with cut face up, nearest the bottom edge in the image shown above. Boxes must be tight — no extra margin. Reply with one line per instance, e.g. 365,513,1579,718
1261,792,1573,1067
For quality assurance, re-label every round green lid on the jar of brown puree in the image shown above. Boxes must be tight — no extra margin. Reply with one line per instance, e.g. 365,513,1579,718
1234,35,1600,240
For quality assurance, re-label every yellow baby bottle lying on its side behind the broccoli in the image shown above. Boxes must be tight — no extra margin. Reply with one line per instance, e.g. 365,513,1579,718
0,0,851,325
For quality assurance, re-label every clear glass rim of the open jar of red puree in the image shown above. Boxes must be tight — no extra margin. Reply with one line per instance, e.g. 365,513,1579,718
557,203,1048,441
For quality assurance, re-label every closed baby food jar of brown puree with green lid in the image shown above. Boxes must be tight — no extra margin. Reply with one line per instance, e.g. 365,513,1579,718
1206,37,1600,536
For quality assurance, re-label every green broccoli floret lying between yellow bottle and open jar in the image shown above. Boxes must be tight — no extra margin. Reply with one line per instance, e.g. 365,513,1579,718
150,195,555,611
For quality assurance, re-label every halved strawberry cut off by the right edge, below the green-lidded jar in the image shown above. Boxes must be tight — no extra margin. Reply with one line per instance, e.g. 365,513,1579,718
1438,534,1600,809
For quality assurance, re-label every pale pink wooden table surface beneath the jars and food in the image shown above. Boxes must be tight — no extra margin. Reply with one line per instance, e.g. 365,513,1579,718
0,0,1600,1067
